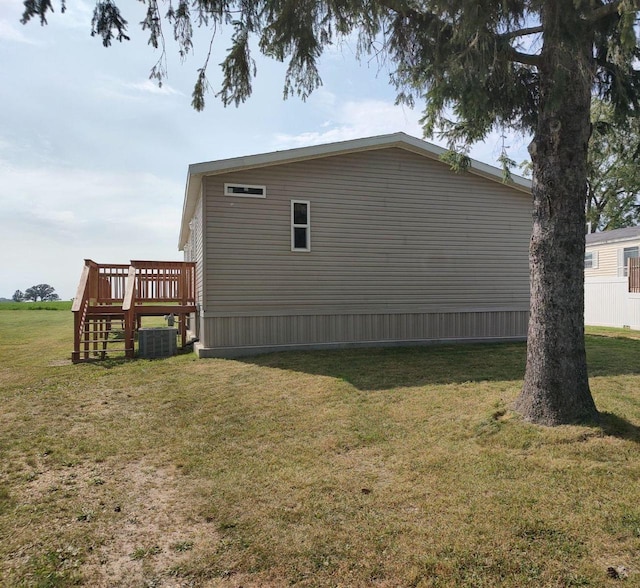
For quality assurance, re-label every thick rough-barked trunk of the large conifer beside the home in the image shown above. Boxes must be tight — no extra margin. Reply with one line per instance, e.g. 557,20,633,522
514,0,598,425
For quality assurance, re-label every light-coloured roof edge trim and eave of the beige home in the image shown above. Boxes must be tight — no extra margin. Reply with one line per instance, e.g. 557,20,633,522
178,133,531,251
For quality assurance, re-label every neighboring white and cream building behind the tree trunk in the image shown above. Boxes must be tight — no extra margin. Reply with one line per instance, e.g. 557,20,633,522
584,227,640,330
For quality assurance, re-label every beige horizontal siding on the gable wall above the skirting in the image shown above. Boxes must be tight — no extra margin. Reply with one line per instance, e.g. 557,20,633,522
204,148,531,324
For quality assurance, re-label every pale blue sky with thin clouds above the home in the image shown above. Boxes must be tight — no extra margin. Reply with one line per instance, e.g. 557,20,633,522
0,0,528,300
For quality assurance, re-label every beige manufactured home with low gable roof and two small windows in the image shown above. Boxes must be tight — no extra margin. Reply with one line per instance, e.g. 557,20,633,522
179,133,532,357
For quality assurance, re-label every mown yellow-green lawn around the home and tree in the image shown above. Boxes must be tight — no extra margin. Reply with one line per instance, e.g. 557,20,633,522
0,312,640,587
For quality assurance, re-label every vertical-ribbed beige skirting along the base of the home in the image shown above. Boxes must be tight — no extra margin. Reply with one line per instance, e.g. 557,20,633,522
194,310,529,358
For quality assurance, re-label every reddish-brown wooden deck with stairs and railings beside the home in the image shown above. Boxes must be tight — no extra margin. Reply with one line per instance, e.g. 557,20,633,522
71,259,196,362
